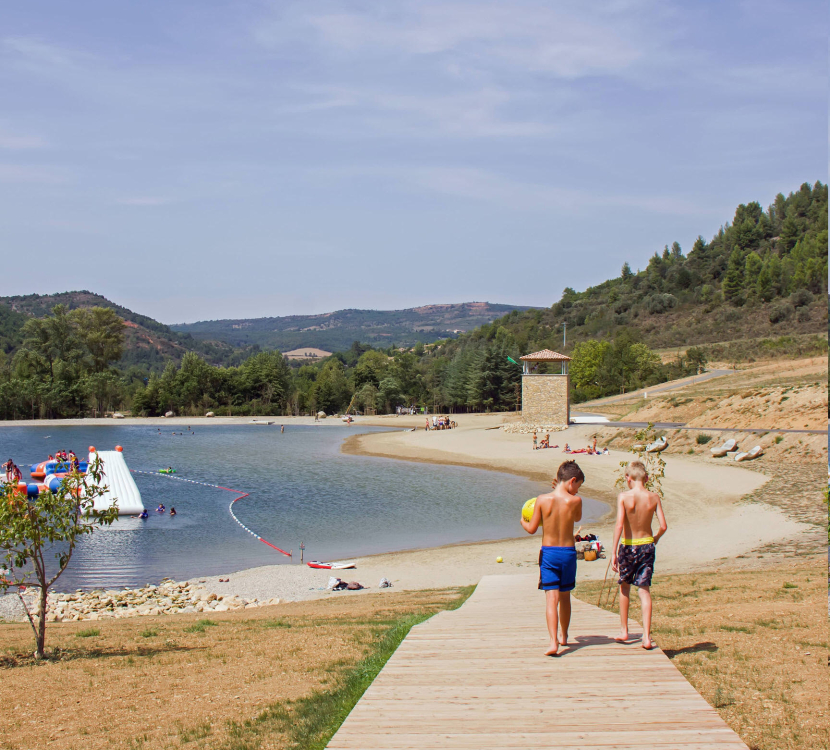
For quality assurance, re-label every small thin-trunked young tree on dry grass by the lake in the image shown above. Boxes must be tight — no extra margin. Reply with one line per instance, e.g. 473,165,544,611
0,460,118,659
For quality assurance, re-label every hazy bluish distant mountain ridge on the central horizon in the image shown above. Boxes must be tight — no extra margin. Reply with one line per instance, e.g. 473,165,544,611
170,302,534,352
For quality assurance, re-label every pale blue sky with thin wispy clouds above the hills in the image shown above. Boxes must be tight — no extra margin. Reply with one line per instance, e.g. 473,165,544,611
0,0,828,323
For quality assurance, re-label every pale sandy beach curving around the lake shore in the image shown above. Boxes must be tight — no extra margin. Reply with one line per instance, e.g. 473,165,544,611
3,414,811,620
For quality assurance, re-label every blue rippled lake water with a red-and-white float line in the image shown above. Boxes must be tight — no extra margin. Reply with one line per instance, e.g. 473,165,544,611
0,425,607,590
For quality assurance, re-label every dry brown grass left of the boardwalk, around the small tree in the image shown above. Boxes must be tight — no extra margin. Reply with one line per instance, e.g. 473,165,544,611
0,589,469,750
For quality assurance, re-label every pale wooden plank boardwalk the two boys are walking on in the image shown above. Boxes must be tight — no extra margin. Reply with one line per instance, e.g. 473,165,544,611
328,576,746,750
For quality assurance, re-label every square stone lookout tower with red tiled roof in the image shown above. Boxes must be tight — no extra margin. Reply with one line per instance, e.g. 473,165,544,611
521,349,571,429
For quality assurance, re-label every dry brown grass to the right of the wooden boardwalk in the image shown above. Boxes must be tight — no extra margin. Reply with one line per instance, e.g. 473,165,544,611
577,556,830,750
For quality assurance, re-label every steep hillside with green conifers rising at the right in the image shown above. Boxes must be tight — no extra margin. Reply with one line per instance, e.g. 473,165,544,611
442,182,827,354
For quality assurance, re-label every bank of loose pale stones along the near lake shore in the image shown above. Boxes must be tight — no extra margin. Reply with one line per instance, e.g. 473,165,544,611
35,579,280,622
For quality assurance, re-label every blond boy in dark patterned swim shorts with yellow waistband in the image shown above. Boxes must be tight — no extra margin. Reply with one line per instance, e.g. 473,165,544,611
611,461,668,650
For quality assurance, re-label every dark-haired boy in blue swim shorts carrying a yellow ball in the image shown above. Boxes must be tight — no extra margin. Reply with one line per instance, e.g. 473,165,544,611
521,461,585,656
